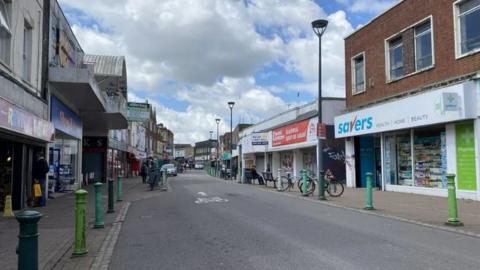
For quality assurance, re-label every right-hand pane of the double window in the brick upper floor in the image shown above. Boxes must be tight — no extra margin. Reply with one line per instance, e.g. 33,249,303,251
415,20,433,71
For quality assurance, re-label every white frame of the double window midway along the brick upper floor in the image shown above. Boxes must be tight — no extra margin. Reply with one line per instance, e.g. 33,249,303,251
384,15,436,84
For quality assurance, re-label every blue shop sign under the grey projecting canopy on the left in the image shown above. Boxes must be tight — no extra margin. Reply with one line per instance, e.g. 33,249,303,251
50,96,83,139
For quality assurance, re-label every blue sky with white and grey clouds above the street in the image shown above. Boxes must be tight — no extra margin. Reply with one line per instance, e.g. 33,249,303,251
59,0,397,143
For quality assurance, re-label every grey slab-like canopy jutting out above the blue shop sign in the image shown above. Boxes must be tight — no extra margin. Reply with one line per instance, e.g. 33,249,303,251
48,67,106,114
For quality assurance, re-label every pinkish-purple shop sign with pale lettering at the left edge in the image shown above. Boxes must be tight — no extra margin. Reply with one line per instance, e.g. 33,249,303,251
0,99,55,141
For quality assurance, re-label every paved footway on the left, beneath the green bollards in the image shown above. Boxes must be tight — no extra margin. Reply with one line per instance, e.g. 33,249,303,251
0,178,161,270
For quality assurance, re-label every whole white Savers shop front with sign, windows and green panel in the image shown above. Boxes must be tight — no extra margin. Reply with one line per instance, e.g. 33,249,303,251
335,82,480,199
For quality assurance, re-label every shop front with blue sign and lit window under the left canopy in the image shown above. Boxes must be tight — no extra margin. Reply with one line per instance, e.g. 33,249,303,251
48,96,83,192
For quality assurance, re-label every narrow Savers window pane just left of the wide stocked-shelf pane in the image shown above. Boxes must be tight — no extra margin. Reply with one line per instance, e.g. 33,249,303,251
397,135,413,186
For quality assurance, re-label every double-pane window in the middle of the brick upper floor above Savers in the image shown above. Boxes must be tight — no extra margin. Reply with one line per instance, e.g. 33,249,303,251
385,16,435,82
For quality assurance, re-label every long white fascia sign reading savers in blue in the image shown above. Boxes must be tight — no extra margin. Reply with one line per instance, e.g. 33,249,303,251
335,82,477,138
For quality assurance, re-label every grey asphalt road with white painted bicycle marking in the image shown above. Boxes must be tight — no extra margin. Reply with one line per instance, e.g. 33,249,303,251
110,172,480,270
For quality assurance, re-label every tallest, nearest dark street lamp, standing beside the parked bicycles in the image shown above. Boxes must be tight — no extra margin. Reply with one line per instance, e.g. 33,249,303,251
312,20,328,200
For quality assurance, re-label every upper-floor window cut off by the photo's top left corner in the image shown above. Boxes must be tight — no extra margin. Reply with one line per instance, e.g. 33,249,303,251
0,0,12,66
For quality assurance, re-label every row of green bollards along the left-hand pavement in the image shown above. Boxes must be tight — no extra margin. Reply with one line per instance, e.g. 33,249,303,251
15,176,123,270
